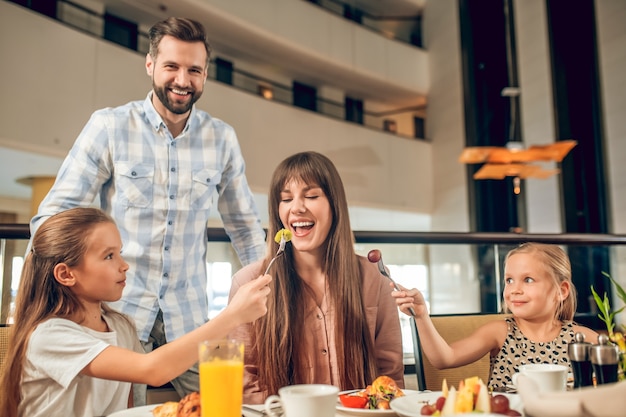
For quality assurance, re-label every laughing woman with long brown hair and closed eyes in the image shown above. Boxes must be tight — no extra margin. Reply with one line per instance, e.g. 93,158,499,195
231,152,404,403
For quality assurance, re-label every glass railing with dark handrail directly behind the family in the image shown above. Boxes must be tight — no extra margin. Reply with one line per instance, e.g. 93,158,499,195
0,224,626,362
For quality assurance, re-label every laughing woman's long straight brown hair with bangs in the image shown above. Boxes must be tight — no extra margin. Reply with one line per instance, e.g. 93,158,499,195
254,152,376,394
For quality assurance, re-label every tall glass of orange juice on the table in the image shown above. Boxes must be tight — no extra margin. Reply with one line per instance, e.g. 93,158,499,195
200,359,243,417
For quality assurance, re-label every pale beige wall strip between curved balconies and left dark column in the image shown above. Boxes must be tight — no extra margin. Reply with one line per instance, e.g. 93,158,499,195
424,0,480,314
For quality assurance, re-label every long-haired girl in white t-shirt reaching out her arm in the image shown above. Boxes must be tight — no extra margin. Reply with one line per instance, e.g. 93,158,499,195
0,208,271,417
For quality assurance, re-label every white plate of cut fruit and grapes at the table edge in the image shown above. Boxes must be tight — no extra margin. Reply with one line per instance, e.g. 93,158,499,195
390,377,524,417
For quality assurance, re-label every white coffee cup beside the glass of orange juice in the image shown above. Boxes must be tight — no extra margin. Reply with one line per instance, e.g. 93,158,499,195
265,384,339,417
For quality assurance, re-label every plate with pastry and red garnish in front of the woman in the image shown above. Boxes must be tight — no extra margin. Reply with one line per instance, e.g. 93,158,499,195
337,376,419,417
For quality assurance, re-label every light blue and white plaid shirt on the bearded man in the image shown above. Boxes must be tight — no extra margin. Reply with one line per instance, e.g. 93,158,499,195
31,92,266,341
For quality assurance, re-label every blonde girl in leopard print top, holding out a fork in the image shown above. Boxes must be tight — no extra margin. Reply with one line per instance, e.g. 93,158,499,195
392,243,598,391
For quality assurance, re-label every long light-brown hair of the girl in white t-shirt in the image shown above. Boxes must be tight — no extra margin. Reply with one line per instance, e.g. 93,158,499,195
0,208,129,416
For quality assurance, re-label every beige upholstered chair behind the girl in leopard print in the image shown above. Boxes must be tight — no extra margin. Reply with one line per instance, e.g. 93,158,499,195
411,314,509,391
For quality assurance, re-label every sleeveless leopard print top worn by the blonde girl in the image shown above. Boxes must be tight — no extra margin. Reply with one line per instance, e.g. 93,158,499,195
489,318,574,391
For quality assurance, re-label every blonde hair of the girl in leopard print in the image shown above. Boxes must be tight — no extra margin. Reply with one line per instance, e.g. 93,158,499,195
504,242,577,321
